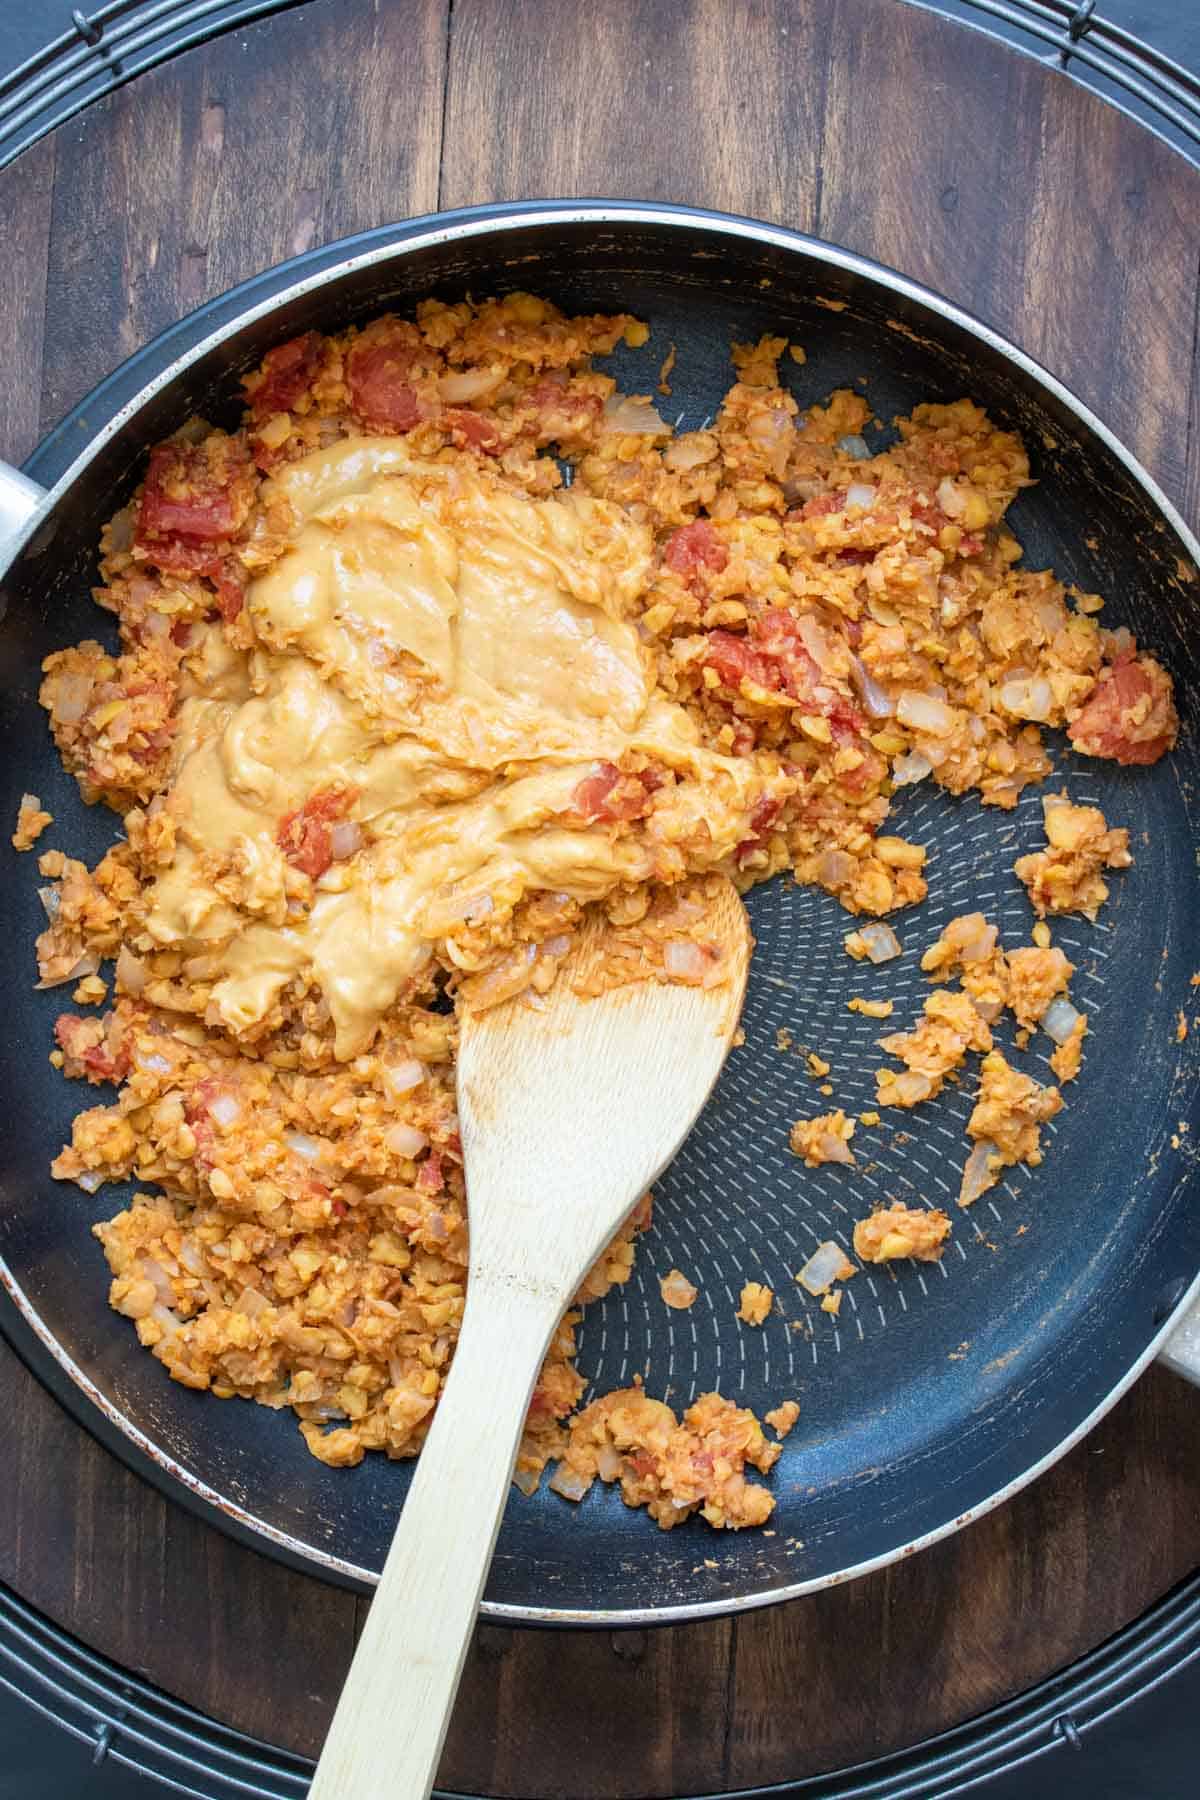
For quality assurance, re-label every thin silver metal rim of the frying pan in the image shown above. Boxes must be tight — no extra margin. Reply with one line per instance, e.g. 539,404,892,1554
0,200,1200,1629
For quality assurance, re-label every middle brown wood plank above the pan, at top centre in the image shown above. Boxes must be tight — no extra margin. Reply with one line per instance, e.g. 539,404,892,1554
441,0,827,230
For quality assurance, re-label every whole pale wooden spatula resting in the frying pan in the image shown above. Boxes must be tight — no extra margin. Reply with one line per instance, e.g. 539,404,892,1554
309,880,752,1800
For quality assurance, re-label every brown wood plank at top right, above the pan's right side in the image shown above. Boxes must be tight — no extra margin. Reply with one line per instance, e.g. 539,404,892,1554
820,0,1200,518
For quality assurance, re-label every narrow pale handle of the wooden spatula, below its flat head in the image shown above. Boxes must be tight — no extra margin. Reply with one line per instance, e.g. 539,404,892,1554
309,1274,563,1800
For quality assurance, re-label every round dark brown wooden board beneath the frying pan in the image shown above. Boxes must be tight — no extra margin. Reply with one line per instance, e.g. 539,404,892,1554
0,0,1200,1800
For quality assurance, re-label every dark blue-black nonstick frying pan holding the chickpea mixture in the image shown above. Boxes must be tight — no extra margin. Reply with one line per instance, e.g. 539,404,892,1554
0,202,1200,1625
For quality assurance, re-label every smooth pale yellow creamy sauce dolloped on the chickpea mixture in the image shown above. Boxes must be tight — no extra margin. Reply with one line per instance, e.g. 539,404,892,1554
146,437,790,1060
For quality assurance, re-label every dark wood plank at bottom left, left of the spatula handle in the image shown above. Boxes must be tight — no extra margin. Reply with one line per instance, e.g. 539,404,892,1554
0,1343,354,1751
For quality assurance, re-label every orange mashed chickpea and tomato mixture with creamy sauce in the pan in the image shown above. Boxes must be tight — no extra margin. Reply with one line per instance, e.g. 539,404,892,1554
32,295,1177,1528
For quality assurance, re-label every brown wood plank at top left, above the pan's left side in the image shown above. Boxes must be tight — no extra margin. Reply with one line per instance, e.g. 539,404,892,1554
41,0,448,427
